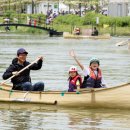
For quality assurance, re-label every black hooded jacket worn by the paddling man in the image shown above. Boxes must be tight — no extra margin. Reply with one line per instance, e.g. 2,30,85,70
3,58,42,86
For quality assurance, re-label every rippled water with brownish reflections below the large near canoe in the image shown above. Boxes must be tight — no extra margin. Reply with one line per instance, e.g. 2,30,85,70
0,104,130,130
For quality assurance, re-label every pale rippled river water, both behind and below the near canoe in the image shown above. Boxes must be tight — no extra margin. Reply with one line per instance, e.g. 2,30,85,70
0,34,130,130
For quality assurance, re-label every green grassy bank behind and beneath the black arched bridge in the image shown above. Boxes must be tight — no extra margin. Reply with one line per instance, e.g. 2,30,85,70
0,10,47,34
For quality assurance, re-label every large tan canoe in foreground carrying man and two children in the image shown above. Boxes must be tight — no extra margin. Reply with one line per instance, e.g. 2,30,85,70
0,83,130,109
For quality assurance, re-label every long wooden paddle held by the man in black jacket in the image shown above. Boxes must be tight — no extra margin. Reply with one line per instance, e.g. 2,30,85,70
0,58,40,85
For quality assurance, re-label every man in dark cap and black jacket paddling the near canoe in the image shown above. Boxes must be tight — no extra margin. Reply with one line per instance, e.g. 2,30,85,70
3,48,44,91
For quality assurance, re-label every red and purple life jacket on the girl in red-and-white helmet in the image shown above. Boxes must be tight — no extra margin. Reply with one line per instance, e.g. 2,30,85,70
68,75,82,92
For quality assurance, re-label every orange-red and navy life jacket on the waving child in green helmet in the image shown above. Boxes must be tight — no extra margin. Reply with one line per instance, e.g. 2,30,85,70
82,68,102,88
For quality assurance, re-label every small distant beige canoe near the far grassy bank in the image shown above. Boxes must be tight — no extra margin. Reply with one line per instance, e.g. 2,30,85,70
63,32,111,39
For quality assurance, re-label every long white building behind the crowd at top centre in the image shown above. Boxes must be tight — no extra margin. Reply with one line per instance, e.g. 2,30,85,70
26,0,85,14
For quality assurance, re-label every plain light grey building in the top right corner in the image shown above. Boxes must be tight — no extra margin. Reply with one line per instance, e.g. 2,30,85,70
108,0,130,17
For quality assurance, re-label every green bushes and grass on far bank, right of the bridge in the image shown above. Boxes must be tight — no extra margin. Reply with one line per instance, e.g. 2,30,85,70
53,12,130,36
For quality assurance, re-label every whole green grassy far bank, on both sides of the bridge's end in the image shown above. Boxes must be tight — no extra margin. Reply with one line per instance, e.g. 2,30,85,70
0,11,130,36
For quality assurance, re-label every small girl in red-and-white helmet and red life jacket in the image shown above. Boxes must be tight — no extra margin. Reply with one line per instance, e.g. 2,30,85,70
68,66,82,92
